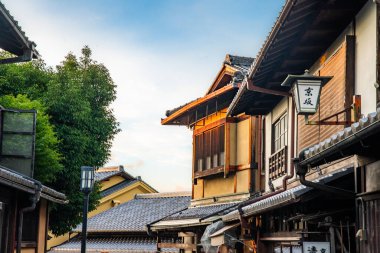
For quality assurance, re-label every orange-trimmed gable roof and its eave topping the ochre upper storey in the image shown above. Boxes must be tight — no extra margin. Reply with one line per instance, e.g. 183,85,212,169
161,54,254,126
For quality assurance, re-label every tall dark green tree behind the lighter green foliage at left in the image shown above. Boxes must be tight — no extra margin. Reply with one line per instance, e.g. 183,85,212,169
0,46,119,235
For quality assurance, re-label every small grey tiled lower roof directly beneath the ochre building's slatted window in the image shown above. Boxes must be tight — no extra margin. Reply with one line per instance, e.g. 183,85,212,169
163,202,238,220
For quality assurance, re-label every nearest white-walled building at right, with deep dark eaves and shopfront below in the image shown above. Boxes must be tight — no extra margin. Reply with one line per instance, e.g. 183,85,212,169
222,0,380,252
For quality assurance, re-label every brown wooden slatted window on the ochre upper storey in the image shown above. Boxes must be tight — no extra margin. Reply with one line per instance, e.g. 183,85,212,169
194,125,225,171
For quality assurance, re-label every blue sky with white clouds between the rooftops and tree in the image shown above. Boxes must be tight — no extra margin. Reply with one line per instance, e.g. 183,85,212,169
1,0,284,191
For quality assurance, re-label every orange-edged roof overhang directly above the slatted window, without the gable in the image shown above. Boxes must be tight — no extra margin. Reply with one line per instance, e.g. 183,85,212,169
161,84,239,126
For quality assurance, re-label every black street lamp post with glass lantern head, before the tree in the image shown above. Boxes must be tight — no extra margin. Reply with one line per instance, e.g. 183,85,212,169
80,166,94,253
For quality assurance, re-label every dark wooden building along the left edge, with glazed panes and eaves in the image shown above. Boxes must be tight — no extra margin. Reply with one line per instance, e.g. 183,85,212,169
0,3,66,253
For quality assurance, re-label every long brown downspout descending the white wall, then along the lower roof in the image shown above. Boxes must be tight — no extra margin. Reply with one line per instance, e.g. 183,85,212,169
238,103,295,223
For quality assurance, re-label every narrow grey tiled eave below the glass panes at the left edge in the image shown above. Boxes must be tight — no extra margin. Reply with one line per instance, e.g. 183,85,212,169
0,166,66,203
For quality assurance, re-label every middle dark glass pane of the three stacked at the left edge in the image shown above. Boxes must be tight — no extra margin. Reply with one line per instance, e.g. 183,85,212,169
2,134,33,157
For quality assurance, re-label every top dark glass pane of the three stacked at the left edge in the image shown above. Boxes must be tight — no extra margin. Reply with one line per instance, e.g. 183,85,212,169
3,111,34,133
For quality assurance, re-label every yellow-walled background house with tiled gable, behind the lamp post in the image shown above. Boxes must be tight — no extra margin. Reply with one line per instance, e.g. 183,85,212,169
47,165,157,250
